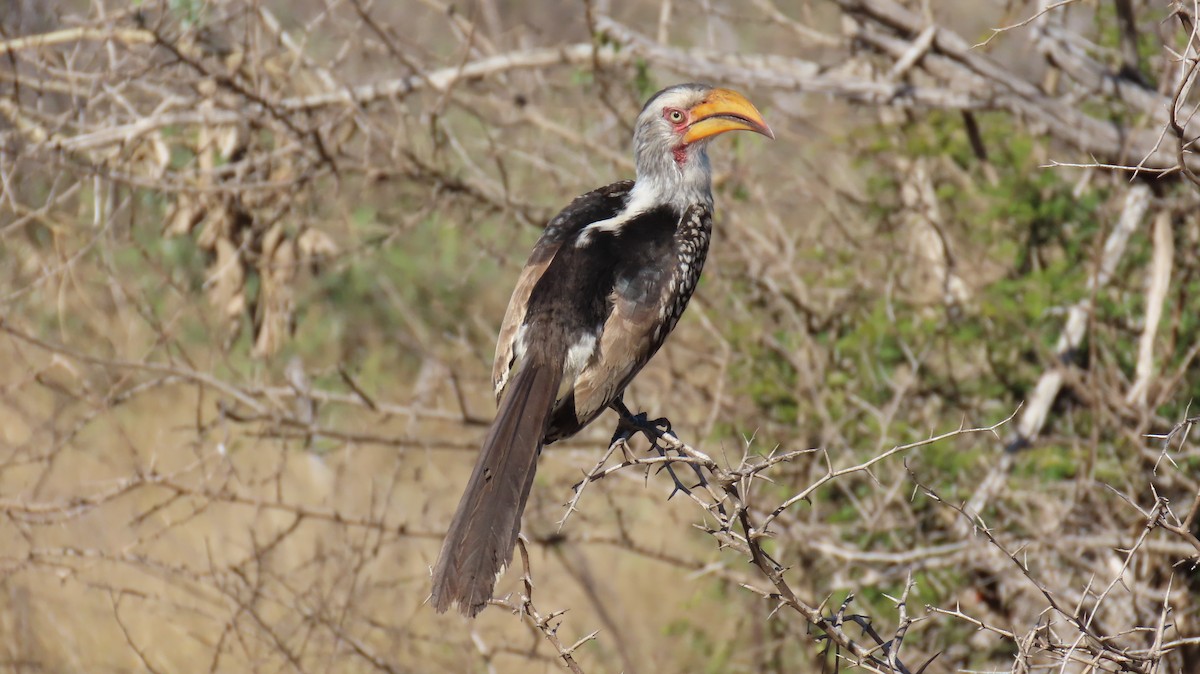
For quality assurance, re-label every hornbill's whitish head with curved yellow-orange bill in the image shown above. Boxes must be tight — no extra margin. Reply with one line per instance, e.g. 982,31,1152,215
634,84,775,206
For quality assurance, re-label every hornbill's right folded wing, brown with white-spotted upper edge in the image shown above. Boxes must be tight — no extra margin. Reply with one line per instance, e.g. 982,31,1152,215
574,206,712,426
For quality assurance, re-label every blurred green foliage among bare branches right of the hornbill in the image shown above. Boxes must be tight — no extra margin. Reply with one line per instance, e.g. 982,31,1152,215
727,107,1132,642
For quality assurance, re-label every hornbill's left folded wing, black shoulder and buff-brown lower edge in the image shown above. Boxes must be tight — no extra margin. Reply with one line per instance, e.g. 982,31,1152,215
492,180,634,401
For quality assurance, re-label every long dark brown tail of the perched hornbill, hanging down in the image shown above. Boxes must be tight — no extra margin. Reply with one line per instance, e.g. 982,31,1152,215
431,340,566,616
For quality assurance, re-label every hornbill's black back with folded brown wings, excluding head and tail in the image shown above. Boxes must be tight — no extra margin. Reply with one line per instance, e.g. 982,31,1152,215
494,182,712,443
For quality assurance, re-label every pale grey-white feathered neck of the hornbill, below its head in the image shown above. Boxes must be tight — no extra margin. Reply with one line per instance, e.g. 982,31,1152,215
626,145,713,213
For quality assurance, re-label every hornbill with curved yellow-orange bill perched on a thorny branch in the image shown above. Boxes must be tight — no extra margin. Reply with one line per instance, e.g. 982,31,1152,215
431,84,775,616
